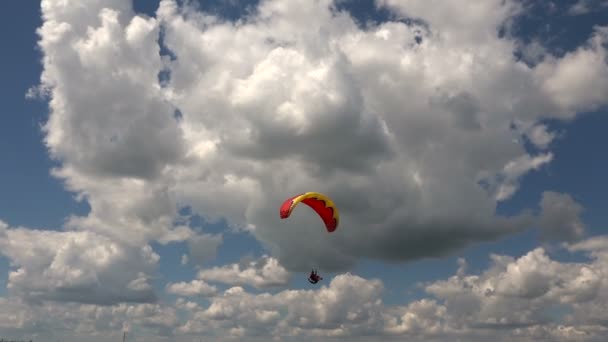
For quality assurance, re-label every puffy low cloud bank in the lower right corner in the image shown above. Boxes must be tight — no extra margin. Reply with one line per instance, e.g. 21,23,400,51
418,238,606,340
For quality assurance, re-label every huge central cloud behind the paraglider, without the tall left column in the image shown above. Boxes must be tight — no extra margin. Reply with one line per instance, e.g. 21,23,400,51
154,1,600,270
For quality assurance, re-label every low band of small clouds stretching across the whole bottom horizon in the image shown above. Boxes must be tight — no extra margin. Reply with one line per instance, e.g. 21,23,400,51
0,236,608,342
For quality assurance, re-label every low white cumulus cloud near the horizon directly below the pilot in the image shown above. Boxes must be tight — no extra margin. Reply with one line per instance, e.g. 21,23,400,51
179,274,382,337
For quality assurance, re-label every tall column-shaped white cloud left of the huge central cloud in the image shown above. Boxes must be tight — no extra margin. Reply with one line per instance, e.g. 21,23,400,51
33,1,192,245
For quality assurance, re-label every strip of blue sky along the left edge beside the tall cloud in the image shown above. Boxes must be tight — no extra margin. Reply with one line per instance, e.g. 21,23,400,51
1,2,88,229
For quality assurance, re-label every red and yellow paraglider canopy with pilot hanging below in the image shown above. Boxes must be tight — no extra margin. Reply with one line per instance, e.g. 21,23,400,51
279,192,340,284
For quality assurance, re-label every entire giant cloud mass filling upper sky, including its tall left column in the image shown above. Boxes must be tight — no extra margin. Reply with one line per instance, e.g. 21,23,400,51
33,0,608,270
